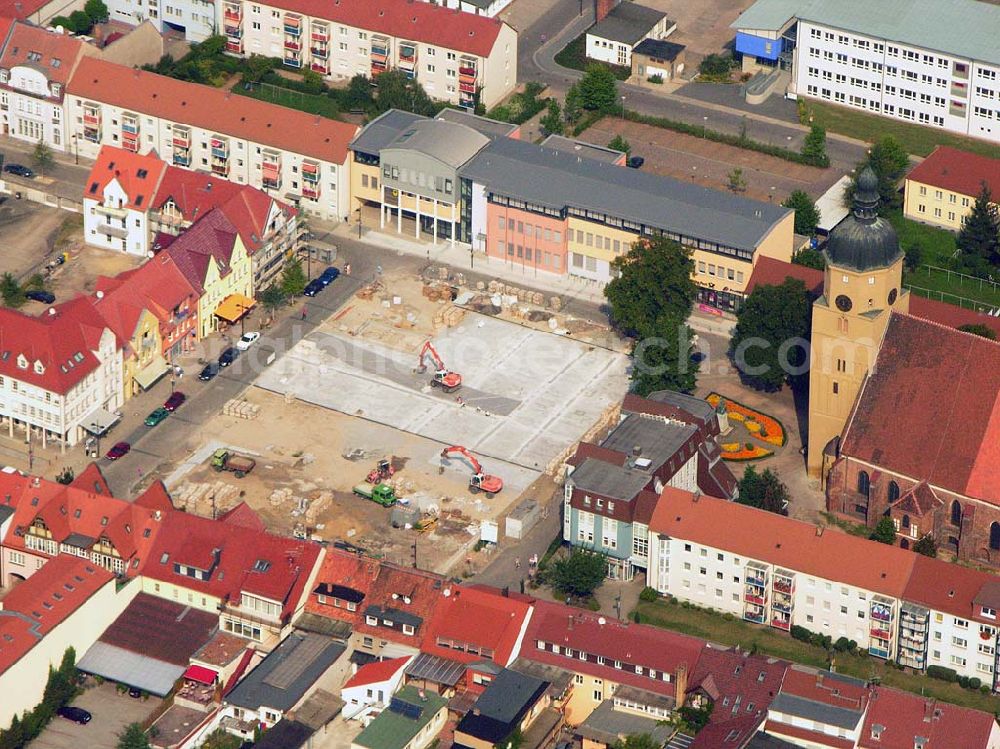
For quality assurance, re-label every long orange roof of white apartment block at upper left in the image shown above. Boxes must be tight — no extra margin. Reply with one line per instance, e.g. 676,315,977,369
68,57,358,164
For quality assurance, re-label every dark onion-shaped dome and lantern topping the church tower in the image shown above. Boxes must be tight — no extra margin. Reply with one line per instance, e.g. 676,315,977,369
825,167,902,271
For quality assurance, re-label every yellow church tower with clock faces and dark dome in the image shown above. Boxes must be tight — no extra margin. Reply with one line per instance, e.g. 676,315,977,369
807,167,910,477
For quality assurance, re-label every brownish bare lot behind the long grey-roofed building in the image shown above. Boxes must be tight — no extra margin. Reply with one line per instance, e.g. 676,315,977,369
580,117,839,202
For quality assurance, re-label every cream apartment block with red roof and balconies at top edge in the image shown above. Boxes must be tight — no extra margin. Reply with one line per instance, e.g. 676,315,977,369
219,0,517,108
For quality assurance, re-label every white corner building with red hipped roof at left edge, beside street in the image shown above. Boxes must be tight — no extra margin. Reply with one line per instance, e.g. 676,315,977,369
0,297,123,449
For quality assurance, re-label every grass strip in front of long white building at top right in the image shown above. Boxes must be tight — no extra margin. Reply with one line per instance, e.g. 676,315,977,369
806,99,1000,158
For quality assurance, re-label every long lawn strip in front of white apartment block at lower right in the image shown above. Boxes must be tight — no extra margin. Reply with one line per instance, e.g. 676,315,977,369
636,599,1000,713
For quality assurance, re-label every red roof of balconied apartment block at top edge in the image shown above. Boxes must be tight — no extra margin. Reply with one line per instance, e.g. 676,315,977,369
267,0,503,57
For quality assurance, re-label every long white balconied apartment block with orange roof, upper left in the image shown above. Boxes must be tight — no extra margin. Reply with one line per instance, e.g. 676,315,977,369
67,58,357,220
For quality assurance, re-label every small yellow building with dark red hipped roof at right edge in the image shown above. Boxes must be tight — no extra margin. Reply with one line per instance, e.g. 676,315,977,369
903,146,1000,232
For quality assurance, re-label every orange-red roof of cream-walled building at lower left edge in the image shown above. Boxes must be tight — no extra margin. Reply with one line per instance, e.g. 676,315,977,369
0,554,114,674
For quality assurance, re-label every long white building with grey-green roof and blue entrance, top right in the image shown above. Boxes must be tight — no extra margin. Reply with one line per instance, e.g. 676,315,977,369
732,0,1000,142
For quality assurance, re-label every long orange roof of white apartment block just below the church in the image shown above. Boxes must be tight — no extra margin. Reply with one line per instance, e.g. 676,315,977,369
649,487,917,598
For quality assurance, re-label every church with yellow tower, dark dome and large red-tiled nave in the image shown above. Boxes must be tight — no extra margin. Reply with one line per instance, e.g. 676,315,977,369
788,169,1000,566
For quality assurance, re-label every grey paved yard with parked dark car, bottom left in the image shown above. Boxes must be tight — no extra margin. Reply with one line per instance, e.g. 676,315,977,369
31,682,161,749
